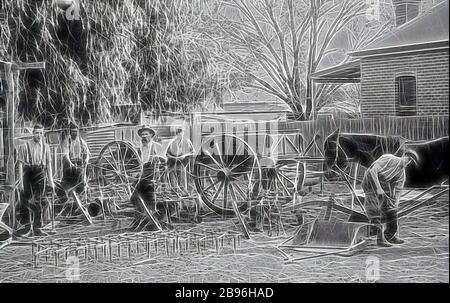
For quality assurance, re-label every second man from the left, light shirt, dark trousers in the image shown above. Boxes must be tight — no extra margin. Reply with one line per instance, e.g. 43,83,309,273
57,122,89,214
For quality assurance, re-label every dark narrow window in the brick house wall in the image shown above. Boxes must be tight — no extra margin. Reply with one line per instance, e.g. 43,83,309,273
395,76,416,116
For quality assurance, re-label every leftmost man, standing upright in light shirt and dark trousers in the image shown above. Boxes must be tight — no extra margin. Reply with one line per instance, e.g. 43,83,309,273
16,124,55,236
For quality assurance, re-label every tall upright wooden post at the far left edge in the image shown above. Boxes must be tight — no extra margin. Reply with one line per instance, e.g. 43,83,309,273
4,63,16,230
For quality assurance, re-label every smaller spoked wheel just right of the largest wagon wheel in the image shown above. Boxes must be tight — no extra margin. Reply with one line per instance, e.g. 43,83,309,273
260,135,305,200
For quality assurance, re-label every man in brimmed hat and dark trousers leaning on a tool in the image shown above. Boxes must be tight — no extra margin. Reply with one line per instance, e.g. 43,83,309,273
130,126,166,231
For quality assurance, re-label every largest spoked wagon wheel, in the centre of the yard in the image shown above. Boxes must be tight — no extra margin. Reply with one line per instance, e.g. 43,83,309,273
193,135,261,216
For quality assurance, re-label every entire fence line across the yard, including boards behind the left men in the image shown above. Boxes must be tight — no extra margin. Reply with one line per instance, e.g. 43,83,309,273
1,116,449,183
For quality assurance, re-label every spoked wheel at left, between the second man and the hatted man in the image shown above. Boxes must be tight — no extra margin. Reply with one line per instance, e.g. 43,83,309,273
96,141,142,201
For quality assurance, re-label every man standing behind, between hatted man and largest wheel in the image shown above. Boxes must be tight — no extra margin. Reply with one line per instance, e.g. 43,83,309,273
166,126,194,191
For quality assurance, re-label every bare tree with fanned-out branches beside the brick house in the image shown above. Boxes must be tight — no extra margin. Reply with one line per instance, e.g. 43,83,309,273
211,0,384,120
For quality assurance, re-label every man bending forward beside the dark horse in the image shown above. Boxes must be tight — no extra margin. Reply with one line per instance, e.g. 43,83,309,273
362,150,419,247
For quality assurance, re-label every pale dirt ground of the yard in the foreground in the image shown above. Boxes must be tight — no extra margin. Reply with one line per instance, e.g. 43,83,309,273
0,186,449,283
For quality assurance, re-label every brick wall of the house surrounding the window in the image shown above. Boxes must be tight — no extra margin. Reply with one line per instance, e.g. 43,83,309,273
361,49,449,117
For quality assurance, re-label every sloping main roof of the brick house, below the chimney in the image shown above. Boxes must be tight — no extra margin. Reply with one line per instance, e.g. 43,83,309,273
350,0,449,57
